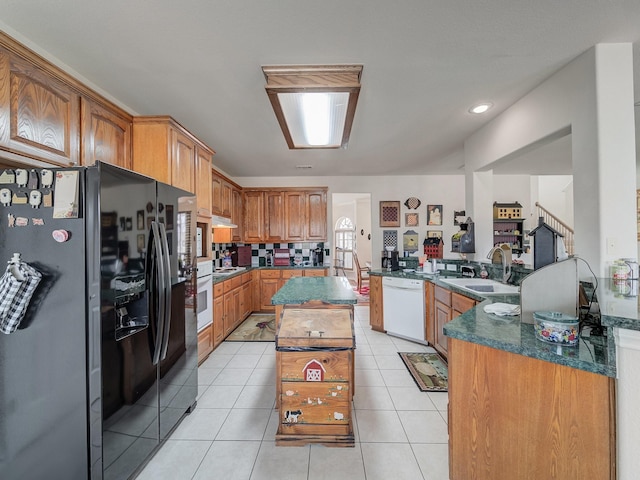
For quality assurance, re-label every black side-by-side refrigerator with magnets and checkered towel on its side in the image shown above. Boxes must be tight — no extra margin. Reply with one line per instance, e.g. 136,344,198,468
0,162,198,480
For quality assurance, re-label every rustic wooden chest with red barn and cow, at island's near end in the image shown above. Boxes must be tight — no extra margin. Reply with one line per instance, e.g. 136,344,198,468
275,302,355,447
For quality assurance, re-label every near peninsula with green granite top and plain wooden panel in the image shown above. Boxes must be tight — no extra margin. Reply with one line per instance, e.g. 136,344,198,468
444,296,616,480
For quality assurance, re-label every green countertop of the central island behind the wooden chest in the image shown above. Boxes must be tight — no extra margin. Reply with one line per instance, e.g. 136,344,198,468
271,277,358,305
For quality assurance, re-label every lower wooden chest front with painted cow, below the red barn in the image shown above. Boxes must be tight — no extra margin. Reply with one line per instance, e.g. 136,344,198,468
280,382,351,425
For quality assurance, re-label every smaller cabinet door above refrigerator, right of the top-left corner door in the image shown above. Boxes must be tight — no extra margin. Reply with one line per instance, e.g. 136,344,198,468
80,97,133,170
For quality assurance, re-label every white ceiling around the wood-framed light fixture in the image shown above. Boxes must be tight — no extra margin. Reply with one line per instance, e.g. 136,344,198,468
0,0,640,177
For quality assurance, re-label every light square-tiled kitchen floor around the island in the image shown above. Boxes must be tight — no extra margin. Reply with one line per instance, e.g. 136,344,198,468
138,306,449,480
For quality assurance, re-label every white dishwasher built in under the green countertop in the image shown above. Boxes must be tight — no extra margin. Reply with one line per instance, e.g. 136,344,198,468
382,277,427,344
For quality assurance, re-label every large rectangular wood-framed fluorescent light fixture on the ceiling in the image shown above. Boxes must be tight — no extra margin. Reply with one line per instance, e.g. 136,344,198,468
262,65,362,149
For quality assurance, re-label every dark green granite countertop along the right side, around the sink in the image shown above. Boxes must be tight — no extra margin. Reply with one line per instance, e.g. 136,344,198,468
371,271,616,377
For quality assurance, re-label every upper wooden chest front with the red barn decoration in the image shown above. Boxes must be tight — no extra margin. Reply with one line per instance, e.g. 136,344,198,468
277,350,353,384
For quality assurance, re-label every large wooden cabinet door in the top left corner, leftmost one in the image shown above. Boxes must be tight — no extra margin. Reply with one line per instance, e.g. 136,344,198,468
0,48,80,167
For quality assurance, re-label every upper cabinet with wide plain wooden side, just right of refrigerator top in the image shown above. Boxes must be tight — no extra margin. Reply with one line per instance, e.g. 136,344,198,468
133,116,204,192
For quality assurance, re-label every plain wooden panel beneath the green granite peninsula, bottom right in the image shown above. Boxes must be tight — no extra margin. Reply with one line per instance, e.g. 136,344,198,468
448,338,616,480
